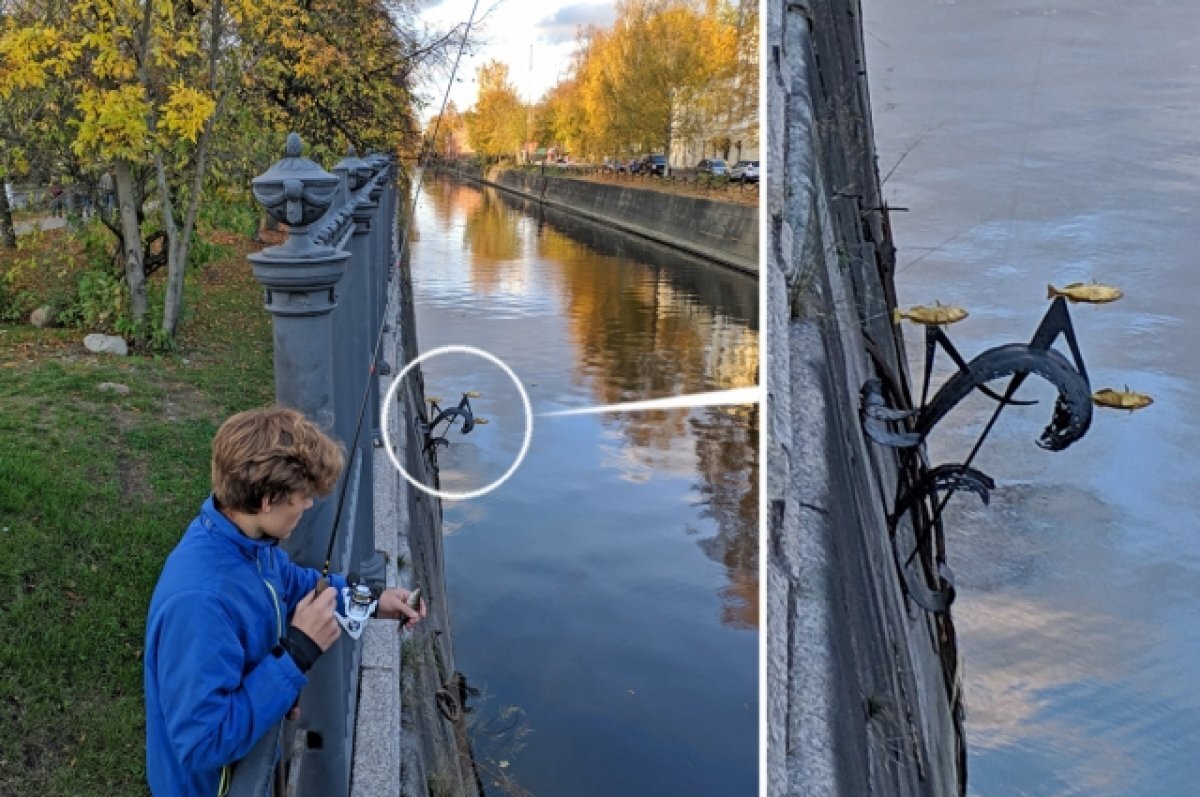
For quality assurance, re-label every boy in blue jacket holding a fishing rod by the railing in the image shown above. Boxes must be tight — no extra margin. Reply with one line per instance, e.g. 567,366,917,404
144,407,424,797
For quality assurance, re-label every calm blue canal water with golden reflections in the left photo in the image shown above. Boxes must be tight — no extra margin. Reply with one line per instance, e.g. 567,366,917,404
412,176,758,797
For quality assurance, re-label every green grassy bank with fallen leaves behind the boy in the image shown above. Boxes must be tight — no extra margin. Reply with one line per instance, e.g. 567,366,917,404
0,222,274,797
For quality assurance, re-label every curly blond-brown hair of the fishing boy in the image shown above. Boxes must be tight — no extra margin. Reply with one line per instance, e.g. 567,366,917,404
212,407,346,514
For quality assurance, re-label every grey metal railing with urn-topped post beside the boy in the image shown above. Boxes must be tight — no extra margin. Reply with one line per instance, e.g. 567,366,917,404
229,133,398,797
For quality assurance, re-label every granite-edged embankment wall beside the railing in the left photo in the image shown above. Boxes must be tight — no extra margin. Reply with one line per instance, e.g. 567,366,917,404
352,189,482,797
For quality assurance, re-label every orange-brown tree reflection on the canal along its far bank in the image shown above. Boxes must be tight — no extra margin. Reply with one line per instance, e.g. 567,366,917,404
540,198,758,614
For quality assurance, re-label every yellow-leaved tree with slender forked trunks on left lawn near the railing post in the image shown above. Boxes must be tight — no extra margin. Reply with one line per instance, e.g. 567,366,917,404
0,0,257,337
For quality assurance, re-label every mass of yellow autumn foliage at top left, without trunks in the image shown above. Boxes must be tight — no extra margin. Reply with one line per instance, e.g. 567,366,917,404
7,0,413,168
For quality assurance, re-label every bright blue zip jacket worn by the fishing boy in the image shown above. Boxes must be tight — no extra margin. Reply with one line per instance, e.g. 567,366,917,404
144,497,346,797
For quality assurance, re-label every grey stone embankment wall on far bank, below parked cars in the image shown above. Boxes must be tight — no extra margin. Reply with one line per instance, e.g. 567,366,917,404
439,160,758,274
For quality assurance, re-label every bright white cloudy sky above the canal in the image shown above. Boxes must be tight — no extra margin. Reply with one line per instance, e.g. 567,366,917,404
418,0,617,120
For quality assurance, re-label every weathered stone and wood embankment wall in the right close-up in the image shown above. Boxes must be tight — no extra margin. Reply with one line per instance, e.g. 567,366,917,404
766,0,965,797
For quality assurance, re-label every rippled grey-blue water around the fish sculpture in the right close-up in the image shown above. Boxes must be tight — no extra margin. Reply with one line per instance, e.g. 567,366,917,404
863,0,1200,797
